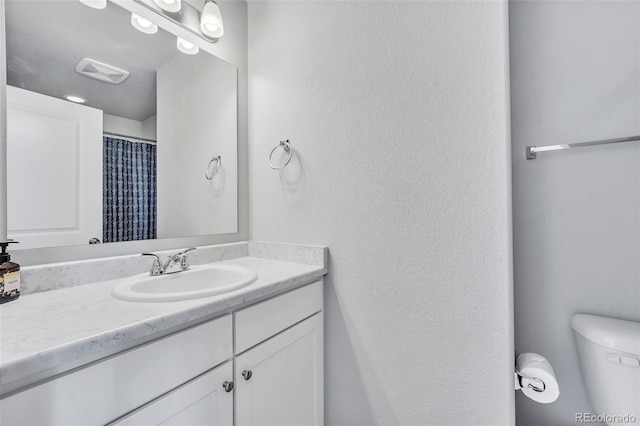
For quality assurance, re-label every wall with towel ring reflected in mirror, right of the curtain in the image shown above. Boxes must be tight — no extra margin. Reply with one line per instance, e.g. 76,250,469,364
156,53,238,238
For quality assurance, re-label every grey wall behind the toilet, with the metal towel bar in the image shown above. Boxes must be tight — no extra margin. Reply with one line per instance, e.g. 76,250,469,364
510,1,640,426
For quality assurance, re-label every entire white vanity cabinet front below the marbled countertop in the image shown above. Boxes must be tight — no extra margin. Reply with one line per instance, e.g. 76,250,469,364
0,281,324,426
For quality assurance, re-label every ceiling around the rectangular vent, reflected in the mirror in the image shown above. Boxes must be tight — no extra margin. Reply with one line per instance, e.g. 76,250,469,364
5,0,180,121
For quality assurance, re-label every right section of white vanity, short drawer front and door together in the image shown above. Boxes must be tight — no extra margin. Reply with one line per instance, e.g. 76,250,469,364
234,282,324,426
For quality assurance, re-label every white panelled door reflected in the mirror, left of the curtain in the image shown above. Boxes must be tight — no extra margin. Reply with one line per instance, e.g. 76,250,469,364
7,86,103,249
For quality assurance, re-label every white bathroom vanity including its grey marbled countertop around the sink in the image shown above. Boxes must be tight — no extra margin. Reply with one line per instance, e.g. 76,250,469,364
0,242,327,425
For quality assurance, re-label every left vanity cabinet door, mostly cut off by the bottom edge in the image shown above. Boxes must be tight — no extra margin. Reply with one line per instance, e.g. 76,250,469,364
111,362,233,426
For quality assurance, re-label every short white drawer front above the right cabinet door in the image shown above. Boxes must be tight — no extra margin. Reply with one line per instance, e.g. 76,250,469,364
234,280,322,354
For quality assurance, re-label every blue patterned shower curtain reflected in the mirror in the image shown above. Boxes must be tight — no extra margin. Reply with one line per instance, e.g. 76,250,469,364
102,137,156,243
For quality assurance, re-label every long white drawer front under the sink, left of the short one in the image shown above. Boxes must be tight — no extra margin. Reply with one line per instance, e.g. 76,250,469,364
0,315,232,426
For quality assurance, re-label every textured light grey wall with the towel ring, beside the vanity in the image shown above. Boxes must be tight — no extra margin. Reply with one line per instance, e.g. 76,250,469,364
249,1,514,425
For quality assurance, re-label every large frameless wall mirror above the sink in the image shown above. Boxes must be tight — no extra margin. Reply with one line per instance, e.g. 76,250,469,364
5,0,238,249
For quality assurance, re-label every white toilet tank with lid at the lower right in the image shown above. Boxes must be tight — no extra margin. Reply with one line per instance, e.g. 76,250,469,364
571,314,640,424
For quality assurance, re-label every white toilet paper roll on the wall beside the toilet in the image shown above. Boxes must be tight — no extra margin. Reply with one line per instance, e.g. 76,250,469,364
516,353,560,404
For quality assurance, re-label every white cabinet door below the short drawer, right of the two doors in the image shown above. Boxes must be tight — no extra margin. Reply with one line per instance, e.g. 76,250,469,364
235,312,324,426
